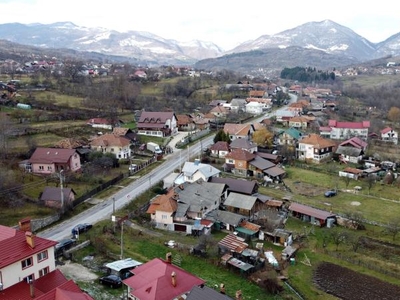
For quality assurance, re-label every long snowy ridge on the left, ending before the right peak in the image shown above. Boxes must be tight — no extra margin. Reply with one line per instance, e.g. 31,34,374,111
0,22,222,64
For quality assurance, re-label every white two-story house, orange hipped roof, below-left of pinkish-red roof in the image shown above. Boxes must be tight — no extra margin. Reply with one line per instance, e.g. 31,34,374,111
296,133,336,163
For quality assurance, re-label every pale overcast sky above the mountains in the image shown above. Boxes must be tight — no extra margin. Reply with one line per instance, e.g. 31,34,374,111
0,0,400,50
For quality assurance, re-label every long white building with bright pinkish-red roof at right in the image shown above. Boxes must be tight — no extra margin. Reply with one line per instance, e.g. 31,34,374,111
320,120,370,140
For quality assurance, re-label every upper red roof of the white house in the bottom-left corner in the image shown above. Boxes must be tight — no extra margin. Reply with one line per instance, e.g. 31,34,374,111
0,225,57,269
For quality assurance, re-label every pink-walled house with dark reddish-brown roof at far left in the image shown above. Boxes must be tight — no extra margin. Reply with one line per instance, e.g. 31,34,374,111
25,148,81,175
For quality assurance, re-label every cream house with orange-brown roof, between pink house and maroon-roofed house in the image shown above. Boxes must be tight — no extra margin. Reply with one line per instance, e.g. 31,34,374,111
90,133,132,159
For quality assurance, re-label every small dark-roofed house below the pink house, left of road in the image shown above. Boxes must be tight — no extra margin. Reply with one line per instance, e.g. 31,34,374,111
39,186,76,209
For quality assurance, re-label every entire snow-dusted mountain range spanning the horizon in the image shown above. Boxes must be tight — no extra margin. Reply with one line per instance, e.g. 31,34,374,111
0,20,400,69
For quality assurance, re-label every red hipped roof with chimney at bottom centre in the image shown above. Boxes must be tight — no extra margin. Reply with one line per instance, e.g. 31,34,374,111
123,258,205,300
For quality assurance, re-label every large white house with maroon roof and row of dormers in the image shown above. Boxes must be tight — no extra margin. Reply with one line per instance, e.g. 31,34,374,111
137,111,178,137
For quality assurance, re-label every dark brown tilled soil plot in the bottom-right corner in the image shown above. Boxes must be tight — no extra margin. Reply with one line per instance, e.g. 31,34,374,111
314,262,400,300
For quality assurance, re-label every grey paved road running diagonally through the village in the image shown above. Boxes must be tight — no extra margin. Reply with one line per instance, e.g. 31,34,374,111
38,98,295,241
